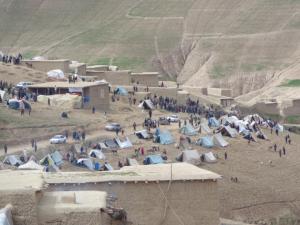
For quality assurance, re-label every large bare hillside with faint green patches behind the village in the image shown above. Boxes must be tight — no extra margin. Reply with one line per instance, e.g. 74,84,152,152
0,0,300,91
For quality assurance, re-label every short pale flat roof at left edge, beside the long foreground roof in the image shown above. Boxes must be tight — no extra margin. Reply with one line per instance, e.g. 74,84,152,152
0,170,44,191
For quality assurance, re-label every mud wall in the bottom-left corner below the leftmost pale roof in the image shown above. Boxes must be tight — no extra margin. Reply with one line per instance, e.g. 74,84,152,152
0,191,38,225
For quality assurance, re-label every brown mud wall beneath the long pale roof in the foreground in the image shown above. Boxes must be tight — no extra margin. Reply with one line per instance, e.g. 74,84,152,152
49,181,219,225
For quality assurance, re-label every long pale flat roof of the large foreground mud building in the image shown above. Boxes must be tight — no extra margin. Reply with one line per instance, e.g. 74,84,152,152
44,163,221,184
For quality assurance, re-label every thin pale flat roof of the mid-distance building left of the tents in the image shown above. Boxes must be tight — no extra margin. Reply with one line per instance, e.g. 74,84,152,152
29,81,107,88
